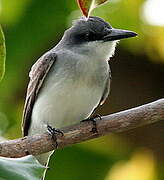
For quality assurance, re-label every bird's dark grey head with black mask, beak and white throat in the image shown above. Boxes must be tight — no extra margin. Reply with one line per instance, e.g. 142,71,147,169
61,16,137,58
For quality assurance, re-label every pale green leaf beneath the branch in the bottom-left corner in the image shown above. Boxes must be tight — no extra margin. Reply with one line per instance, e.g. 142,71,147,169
0,155,45,180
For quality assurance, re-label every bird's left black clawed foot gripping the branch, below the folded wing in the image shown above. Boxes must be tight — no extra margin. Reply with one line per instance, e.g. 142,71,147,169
47,125,64,149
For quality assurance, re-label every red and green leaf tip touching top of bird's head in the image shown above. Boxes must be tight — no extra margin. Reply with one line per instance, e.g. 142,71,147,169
77,0,108,17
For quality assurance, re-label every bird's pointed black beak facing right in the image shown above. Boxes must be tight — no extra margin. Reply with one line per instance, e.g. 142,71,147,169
103,28,137,41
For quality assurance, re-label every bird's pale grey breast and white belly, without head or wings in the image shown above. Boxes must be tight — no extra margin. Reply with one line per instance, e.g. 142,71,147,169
29,50,109,134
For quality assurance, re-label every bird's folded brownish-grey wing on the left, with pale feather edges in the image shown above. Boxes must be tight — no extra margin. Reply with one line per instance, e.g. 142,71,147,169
22,51,57,136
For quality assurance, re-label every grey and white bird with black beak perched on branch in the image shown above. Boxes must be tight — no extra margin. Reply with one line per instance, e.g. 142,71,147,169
22,16,137,174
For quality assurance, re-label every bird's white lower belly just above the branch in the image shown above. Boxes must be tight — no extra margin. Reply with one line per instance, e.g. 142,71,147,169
29,78,103,134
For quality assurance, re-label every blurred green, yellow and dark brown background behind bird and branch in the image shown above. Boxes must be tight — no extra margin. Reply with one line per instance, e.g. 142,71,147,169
0,0,164,180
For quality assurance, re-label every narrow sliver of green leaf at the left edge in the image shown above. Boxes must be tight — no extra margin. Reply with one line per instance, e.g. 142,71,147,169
0,26,6,81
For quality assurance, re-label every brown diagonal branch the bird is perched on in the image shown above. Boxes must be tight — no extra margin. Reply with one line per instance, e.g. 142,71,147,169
0,99,164,157
